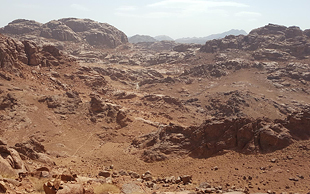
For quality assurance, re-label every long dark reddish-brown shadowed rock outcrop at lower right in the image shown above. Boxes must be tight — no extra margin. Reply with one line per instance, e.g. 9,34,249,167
132,110,310,162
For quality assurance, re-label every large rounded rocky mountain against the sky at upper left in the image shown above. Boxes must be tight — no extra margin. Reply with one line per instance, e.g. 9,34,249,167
0,18,128,48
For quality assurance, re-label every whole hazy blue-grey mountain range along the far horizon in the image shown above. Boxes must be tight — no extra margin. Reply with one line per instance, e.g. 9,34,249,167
128,29,247,44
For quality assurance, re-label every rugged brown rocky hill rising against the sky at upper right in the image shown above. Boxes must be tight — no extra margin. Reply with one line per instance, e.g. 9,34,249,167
200,24,310,60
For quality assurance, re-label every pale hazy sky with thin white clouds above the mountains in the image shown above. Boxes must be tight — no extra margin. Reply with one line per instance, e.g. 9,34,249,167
0,0,310,39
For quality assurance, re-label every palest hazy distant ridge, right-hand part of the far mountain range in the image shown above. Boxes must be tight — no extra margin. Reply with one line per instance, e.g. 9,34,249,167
175,29,247,44
